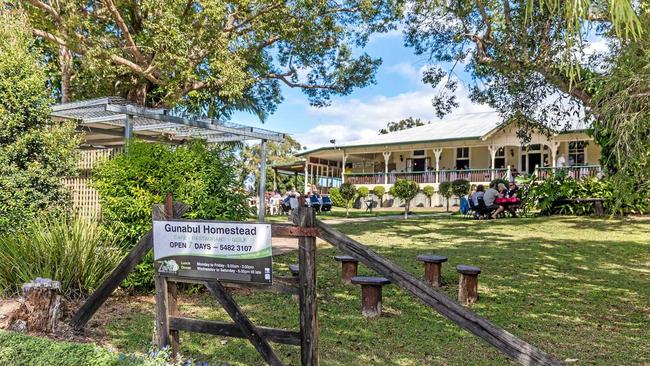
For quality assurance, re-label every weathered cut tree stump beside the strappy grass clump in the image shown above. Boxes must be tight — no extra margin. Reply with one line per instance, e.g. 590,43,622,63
10,277,61,333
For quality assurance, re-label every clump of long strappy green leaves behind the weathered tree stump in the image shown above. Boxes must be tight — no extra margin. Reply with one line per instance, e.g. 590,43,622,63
0,216,122,297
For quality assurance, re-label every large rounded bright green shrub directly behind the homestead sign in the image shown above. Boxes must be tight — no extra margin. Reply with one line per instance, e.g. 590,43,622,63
93,140,251,289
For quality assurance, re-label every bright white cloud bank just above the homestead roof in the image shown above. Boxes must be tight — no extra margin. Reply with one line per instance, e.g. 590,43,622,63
295,84,490,149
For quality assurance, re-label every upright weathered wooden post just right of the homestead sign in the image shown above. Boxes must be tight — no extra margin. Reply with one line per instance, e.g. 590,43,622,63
296,202,318,366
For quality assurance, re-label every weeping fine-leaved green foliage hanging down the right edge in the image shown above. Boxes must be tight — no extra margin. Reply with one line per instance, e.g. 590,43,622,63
594,11,650,213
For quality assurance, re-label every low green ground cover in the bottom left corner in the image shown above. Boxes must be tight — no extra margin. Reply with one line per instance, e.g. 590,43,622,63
0,331,118,366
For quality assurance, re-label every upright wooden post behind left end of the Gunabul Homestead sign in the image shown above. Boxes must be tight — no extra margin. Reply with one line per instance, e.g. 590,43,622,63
153,193,180,357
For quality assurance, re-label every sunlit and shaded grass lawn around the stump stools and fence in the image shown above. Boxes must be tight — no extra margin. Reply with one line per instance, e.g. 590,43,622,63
0,217,650,366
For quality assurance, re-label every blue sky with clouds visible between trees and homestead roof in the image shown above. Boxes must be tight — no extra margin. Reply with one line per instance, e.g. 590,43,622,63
232,26,604,149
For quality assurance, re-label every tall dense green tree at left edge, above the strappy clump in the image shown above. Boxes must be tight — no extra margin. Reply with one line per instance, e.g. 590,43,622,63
0,12,79,233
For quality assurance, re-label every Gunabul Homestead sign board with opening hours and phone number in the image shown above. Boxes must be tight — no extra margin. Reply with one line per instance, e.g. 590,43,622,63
153,220,272,284
